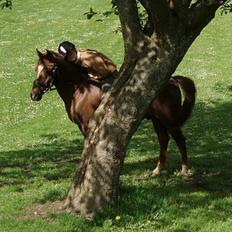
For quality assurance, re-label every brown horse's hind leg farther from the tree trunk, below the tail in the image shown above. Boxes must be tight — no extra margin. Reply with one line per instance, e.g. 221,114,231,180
169,128,188,176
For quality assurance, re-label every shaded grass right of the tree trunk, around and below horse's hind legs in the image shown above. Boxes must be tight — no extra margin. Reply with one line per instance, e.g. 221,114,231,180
94,99,232,227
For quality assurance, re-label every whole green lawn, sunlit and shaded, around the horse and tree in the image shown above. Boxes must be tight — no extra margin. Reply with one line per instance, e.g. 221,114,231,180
0,0,232,232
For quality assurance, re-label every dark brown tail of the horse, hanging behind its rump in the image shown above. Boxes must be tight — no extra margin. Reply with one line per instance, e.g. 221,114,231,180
173,76,196,126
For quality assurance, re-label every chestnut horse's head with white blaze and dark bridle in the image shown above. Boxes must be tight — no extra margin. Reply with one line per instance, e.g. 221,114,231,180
31,50,62,101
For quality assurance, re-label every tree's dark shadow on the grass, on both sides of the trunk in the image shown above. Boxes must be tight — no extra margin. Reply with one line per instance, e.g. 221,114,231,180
0,102,232,228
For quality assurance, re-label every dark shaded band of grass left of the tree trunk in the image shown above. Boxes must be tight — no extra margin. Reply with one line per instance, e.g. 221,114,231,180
0,134,83,187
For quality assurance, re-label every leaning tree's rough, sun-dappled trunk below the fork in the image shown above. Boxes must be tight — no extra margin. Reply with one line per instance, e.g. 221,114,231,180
66,35,192,214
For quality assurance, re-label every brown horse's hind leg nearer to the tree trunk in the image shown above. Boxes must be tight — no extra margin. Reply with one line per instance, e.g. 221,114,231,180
152,119,169,176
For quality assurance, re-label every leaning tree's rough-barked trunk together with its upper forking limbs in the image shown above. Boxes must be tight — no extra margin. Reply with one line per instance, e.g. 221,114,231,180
65,0,225,215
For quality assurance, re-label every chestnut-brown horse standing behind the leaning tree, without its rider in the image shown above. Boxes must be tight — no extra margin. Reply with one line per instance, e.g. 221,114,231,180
31,50,196,176
